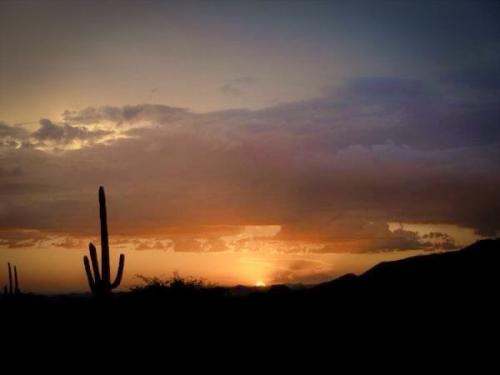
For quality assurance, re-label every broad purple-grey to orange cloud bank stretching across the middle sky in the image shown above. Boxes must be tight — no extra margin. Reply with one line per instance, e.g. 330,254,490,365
0,77,500,253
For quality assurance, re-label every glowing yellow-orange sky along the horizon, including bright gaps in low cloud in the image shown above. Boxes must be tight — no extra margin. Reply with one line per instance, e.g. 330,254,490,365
0,223,480,293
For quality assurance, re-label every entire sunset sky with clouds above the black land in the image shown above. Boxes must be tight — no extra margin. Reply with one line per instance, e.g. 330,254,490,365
0,0,500,293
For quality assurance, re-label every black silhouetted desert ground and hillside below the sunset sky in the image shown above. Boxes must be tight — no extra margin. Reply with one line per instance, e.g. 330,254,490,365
0,240,500,362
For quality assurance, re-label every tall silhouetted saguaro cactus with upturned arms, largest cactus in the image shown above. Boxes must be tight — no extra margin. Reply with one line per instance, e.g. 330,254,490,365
83,186,125,297
